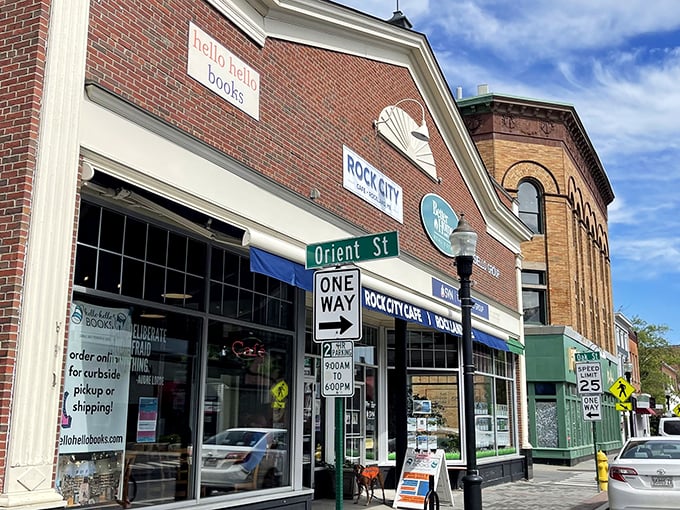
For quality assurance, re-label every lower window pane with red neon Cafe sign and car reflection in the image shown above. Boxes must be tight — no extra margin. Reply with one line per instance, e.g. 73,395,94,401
201,321,293,496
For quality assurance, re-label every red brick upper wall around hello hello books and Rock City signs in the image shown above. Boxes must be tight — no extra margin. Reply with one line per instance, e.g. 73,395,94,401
87,0,516,307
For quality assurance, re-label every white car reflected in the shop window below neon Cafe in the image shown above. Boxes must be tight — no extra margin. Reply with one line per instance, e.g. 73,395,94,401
201,428,288,491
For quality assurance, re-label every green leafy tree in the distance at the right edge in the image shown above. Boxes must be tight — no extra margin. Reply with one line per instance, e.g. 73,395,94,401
632,316,680,403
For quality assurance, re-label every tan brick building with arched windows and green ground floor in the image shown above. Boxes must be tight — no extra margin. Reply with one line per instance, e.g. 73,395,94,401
458,90,621,463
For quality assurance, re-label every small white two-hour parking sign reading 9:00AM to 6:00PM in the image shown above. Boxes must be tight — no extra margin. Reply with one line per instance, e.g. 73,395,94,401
321,340,354,397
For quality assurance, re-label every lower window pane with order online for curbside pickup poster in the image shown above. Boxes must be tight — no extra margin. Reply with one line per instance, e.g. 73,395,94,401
57,297,201,506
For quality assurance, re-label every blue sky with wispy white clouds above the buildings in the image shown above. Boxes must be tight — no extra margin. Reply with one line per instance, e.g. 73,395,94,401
338,0,680,344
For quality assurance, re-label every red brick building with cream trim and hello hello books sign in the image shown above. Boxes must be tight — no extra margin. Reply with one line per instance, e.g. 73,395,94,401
0,0,530,509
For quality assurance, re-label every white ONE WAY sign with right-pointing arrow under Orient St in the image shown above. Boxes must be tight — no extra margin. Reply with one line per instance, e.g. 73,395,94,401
314,267,361,342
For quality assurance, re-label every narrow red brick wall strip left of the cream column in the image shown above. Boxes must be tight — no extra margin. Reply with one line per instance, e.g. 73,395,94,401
0,0,50,489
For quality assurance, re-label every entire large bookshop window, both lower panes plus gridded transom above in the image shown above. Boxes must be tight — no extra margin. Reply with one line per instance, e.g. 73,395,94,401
56,201,295,508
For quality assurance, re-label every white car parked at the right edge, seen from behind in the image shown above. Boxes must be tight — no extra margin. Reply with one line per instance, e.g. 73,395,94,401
608,436,680,510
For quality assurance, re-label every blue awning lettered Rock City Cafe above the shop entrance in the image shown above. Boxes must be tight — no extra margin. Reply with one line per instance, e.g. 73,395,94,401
250,247,510,351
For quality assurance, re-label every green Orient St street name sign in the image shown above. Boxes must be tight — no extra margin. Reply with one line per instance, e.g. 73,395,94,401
305,232,399,269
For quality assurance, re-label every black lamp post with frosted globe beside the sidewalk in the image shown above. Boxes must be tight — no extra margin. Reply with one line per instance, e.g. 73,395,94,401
449,214,482,510
